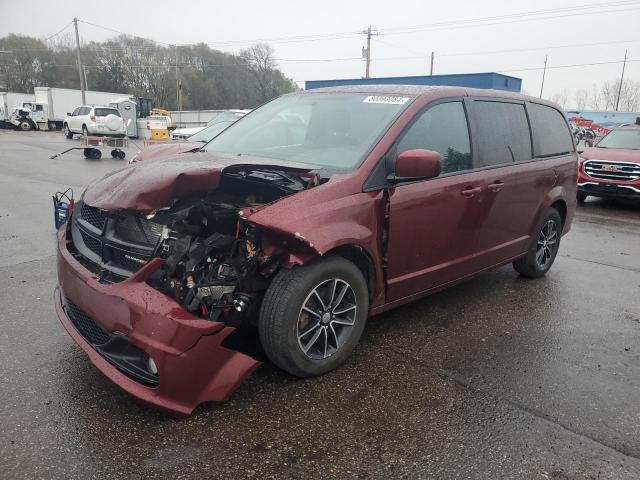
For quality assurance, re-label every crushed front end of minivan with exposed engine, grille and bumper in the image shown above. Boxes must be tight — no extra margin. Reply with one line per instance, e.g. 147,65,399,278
55,163,313,415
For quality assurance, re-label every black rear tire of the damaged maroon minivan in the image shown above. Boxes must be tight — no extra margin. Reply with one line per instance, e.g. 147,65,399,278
513,208,562,278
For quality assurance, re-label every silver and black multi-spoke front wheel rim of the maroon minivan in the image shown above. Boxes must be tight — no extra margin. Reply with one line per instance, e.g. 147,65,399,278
296,278,357,360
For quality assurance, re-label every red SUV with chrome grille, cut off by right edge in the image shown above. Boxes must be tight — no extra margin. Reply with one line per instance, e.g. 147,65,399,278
578,125,640,202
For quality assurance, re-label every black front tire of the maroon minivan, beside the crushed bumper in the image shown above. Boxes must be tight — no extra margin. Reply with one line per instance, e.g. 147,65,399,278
258,256,369,377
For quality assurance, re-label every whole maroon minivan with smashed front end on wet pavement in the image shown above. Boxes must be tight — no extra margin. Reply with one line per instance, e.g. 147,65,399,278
55,86,577,415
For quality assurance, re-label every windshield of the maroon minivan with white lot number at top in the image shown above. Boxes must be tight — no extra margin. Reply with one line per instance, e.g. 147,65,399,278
205,93,411,169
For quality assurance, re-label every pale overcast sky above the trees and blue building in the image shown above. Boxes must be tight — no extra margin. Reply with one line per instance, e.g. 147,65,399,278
0,0,640,106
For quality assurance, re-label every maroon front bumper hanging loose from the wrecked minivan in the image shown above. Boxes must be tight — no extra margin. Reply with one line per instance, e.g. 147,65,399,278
54,224,259,415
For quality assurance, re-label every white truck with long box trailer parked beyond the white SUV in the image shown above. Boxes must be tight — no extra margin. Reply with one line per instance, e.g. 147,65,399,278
10,87,127,130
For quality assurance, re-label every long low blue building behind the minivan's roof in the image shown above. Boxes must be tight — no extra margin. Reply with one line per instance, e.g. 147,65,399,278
304,72,522,92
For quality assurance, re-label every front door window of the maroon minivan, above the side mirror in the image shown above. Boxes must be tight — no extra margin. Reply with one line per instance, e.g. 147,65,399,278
396,102,472,174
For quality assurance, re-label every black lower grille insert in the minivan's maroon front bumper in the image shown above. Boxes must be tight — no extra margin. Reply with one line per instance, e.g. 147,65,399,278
62,295,159,387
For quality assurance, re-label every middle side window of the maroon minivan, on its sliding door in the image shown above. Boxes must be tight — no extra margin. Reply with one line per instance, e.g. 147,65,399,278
474,101,532,168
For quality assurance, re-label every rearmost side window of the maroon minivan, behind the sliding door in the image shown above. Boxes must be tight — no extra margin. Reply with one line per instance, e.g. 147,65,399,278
527,103,573,157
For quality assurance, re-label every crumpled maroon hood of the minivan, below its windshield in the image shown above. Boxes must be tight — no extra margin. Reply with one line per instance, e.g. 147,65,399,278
83,152,313,213
